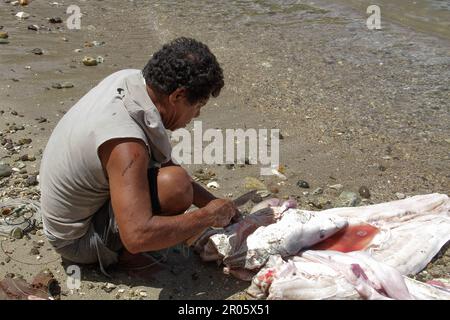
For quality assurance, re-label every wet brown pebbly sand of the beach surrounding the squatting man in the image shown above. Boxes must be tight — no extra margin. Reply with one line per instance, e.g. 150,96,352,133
0,0,450,299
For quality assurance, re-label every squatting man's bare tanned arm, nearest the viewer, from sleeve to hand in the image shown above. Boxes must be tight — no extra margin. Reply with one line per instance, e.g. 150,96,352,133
99,139,236,253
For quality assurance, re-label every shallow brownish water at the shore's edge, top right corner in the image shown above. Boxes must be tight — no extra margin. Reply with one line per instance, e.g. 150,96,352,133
152,0,450,40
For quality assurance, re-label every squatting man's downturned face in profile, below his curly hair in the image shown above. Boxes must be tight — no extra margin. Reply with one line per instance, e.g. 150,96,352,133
167,91,208,131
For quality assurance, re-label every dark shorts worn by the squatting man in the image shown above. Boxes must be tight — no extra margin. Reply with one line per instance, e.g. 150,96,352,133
44,167,161,275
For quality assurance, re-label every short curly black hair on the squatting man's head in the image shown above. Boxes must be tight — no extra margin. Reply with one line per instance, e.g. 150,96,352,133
142,37,224,103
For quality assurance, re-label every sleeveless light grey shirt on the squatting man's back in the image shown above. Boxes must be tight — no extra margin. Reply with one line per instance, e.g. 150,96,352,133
39,69,171,240
